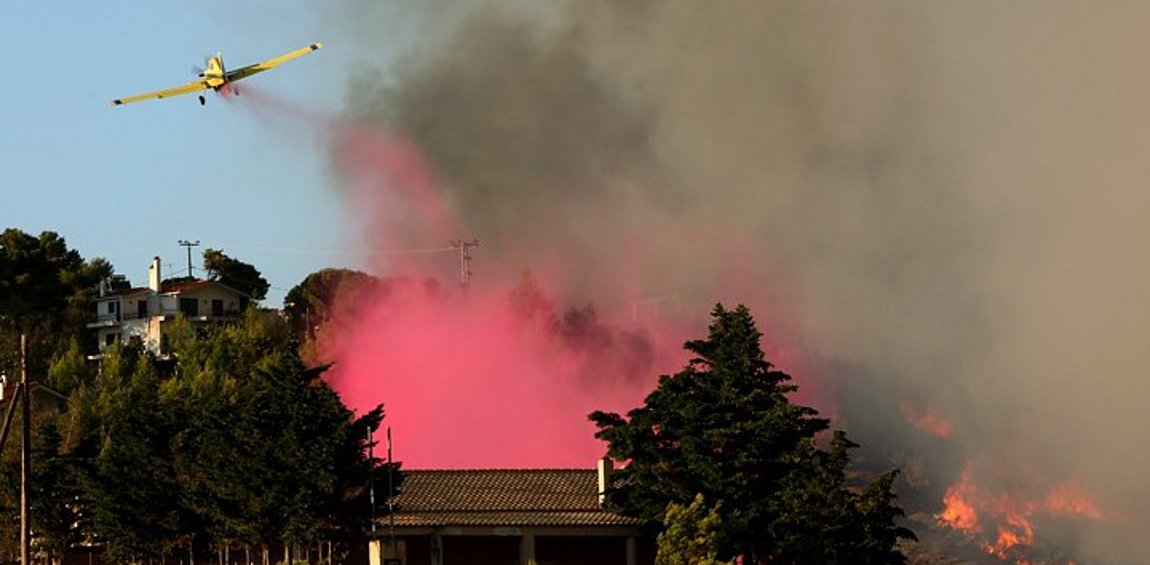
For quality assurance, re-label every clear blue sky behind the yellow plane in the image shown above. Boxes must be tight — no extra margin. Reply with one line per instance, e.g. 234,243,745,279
0,0,386,306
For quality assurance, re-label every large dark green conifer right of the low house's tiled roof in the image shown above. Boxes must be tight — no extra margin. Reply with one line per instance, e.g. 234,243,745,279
590,305,911,564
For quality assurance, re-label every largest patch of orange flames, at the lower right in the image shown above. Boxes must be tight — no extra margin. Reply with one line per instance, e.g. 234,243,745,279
936,464,1103,559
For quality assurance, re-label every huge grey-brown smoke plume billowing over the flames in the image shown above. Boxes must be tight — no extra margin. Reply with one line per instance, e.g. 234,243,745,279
328,0,1150,563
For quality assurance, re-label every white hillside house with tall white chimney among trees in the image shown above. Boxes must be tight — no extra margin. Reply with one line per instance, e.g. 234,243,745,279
87,257,250,353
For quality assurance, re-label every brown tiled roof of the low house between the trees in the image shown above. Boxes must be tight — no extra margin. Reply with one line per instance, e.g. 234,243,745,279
394,469,639,527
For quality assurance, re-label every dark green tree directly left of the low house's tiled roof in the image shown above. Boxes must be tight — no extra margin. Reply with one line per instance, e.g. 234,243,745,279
162,310,397,559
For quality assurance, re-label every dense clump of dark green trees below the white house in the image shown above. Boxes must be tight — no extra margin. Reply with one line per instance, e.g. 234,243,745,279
15,308,403,563
